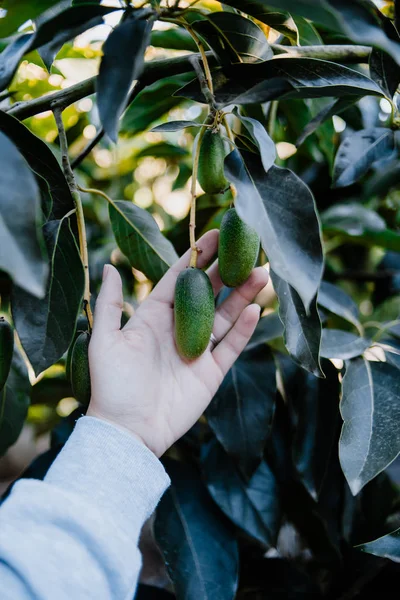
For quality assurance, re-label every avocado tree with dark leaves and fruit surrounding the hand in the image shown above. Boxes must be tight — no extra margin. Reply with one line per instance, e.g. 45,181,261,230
0,0,400,600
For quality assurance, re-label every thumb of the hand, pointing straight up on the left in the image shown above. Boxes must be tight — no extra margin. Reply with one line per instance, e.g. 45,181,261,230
93,265,123,336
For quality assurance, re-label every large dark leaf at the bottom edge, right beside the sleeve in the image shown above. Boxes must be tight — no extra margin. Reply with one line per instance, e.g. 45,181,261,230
154,460,238,600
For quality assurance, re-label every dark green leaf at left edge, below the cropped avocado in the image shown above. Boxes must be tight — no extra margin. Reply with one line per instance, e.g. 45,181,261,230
0,347,31,456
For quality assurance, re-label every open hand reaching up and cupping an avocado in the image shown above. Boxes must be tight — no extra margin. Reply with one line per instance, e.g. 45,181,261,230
87,230,268,457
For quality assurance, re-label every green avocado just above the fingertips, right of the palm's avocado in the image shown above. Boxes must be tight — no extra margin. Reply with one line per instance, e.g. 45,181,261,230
218,208,260,287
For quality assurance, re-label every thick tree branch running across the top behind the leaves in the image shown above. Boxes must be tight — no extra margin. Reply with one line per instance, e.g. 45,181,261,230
7,44,371,120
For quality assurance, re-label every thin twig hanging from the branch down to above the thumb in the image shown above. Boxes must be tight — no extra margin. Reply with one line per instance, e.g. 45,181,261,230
53,105,93,330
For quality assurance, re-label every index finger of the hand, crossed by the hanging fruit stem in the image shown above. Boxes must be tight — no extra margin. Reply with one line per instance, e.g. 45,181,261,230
150,229,219,304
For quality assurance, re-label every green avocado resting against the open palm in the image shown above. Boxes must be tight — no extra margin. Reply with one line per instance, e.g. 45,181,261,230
174,267,215,360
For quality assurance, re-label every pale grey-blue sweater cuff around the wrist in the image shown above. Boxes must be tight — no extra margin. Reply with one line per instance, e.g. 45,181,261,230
45,417,170,528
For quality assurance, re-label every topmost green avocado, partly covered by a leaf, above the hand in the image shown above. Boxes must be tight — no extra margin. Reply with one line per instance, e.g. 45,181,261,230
197,129,229,194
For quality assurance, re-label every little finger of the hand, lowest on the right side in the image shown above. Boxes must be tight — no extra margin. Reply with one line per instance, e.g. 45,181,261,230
212,304,260,376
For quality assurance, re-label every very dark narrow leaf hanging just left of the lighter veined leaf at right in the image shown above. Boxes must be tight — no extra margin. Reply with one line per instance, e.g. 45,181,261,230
278,359,340,500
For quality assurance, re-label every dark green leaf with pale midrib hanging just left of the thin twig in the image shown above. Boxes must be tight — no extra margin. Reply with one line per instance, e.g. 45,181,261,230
12,218,84,375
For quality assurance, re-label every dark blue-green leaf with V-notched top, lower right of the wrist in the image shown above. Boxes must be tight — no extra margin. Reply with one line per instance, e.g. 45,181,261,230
202,440,281,546
